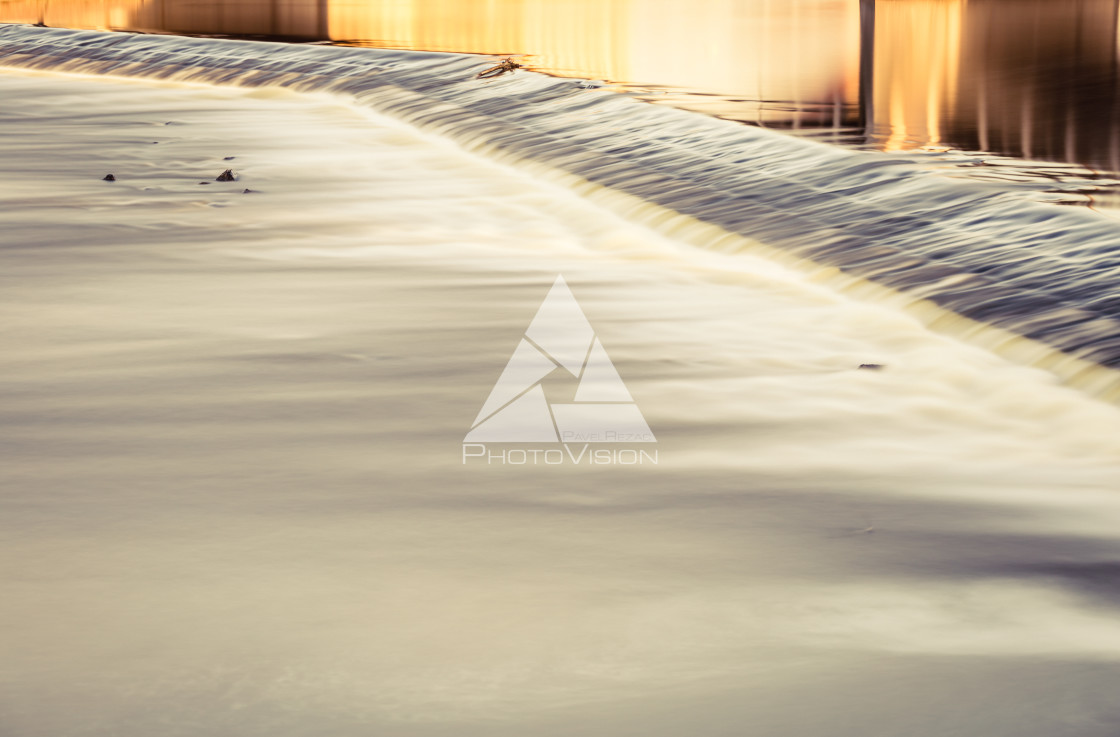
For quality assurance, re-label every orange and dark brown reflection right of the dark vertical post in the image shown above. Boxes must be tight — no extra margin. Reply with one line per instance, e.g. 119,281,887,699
872,0,1120,169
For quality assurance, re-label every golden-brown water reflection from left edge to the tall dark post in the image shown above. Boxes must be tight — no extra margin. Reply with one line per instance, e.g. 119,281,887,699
0,0,859,127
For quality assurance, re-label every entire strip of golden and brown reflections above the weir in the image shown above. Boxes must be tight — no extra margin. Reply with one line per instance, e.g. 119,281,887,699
0,0,1120,170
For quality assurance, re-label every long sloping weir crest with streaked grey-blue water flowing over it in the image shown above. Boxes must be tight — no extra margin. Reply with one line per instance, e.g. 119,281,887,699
0,26,1120,401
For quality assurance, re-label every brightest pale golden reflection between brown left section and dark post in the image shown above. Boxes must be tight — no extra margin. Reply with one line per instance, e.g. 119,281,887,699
330,0,859,124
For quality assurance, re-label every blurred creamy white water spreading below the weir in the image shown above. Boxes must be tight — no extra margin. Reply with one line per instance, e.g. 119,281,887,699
0,66,1120,737
